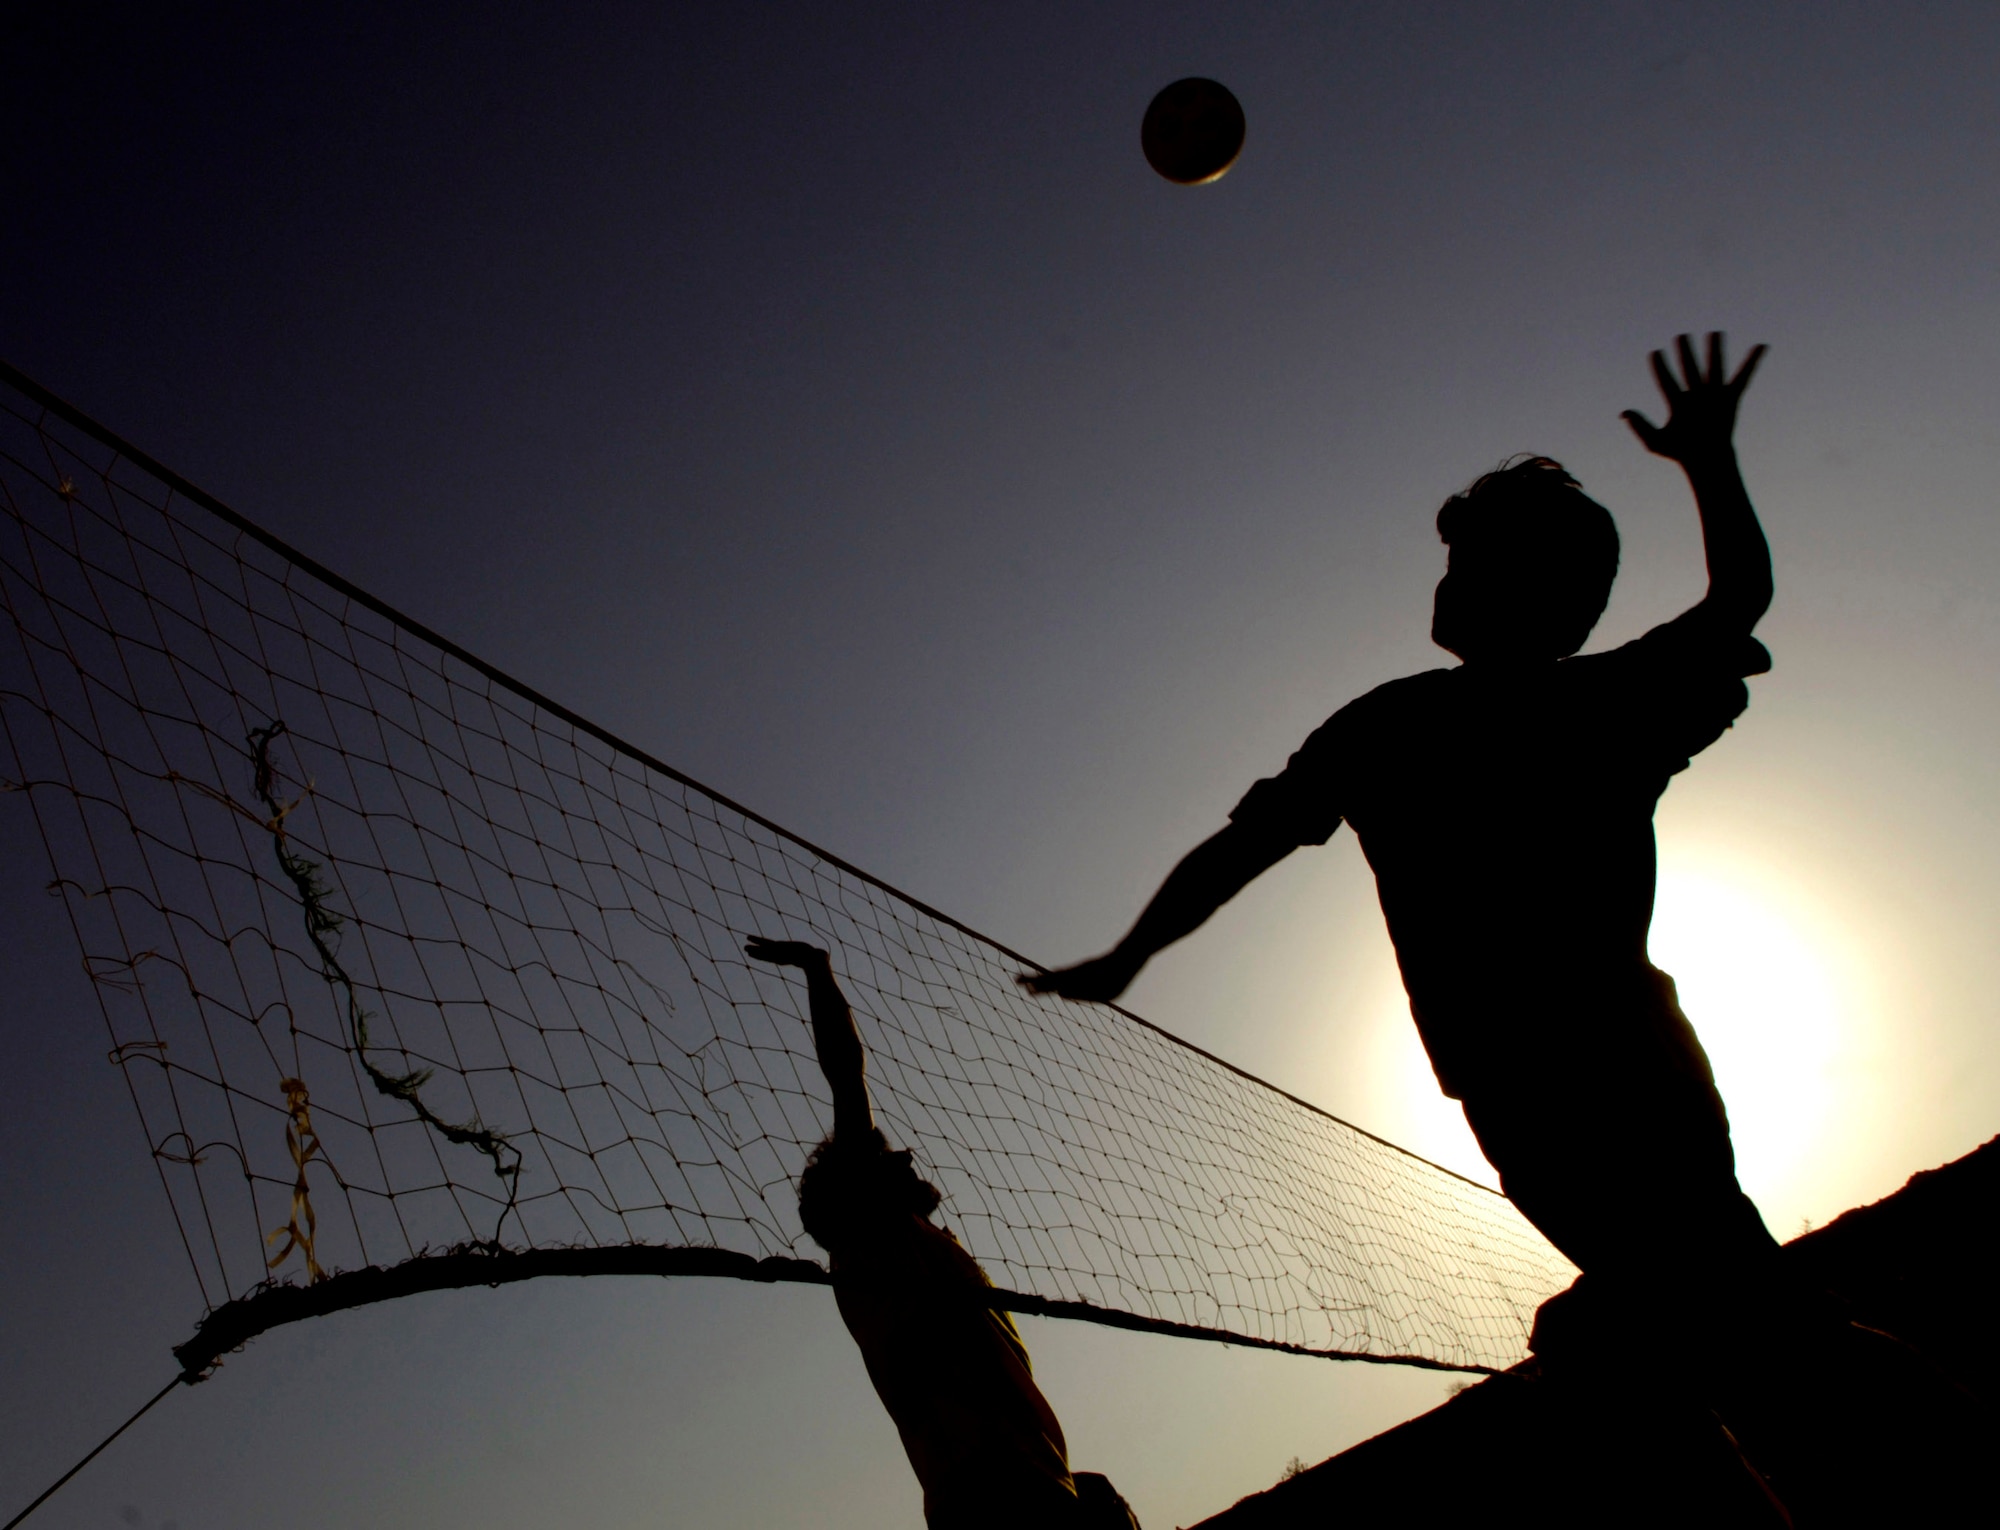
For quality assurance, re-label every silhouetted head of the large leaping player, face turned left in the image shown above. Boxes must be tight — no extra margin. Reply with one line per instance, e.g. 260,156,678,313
1430,456,1618,660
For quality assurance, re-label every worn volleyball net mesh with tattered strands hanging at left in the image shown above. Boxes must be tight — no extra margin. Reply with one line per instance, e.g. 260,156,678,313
0,370,1572,1368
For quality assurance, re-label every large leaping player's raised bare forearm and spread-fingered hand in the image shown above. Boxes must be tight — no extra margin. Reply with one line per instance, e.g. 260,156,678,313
1622,332,1772,636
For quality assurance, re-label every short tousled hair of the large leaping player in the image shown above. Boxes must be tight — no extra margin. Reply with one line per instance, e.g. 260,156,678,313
1438,454,1618,654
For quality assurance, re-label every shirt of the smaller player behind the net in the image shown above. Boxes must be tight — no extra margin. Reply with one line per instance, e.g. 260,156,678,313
828,1144,1078,1530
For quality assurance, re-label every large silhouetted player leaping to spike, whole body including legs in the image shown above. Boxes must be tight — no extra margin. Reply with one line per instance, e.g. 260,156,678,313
1022,334,1992,1526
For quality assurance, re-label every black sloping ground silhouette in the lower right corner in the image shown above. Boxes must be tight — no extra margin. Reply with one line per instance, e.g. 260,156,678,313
1196,1138,2000,1530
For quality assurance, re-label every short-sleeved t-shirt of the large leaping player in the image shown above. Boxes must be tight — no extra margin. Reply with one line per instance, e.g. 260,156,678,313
1230,610,1770,1098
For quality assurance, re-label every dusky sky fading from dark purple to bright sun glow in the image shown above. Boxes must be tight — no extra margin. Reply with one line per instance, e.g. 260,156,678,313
0,0,2000,1530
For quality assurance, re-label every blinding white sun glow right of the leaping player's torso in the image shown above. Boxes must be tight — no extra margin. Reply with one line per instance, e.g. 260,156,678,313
1650,868,1854,1238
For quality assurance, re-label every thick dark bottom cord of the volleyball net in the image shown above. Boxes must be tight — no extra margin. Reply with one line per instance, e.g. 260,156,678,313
174,1244,1500,1384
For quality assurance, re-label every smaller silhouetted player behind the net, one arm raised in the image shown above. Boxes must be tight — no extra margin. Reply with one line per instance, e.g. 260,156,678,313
744,938,1138,1530
